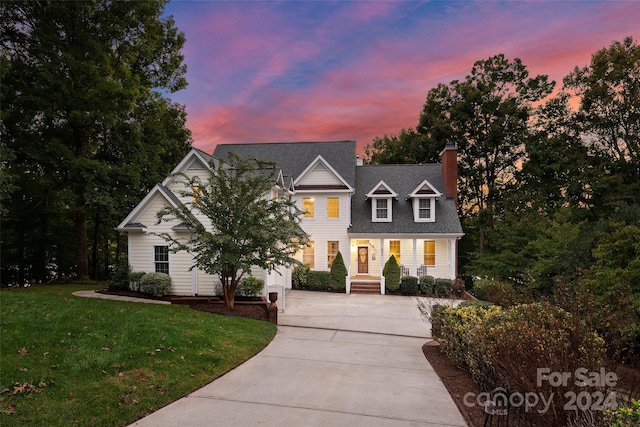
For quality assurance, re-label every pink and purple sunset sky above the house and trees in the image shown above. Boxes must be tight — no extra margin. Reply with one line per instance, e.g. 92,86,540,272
165,0,640,152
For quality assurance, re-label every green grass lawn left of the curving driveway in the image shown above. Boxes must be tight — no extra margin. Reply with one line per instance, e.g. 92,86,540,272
0,285,276,427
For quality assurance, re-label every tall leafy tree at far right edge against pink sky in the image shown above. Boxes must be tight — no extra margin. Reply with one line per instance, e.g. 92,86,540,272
564,37,640,215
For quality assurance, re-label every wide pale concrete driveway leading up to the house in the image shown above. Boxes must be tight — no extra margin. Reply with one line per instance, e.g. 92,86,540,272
133,291,466,427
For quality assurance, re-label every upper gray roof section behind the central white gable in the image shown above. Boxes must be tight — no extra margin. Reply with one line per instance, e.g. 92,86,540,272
213,141,356,188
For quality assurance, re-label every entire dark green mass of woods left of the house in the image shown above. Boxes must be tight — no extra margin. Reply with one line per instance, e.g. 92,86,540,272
0,0,190,280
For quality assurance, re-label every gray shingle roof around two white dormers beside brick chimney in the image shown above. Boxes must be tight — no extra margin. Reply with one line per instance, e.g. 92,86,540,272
349,163,462,234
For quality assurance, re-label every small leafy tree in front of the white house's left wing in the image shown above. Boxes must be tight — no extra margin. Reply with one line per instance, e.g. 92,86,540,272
158,154,307,307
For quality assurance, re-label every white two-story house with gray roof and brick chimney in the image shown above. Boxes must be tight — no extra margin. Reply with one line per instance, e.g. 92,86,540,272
118,141,463,295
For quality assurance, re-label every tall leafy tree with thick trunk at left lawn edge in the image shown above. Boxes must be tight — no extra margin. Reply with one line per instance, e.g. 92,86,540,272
0,0,186,277
